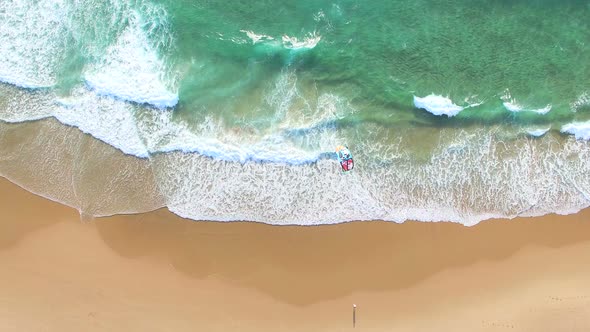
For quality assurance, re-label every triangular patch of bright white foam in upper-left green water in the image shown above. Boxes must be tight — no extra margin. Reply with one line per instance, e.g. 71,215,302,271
85,12,178,108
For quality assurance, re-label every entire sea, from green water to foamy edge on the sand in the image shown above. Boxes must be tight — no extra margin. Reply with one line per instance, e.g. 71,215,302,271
0,0,590,225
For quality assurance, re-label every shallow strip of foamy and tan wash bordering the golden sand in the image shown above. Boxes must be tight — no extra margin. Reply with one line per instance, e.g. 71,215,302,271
0,118,590,225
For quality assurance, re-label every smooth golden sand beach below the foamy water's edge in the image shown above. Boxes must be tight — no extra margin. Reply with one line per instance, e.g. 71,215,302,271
0,175,590,332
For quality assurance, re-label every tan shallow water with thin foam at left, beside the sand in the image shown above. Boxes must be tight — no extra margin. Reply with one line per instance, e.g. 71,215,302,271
0,119,165,216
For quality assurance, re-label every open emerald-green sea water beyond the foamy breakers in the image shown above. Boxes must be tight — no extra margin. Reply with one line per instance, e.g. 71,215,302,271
162,1,590,126
